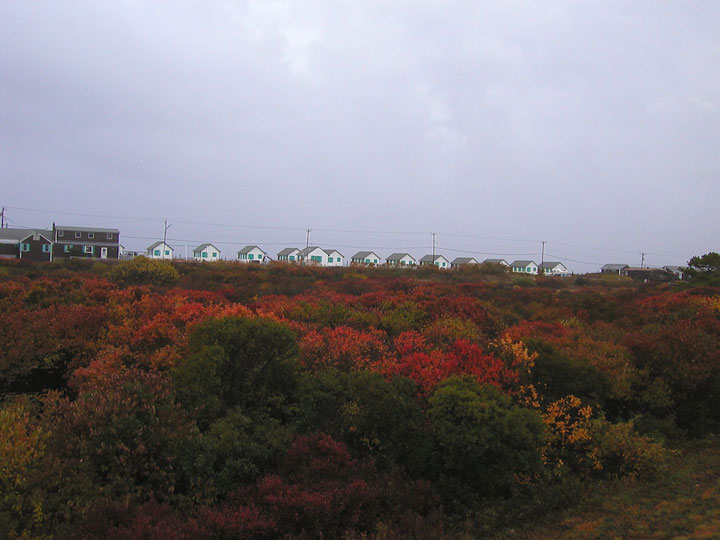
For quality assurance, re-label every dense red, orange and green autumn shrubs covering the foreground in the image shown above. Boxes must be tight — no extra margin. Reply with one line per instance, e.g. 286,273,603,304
0,259,720,540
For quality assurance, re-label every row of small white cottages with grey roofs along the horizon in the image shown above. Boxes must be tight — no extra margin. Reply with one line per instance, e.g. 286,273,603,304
147,242,569,276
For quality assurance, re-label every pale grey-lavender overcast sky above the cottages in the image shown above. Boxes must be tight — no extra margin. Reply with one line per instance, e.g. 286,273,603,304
0,0,720,272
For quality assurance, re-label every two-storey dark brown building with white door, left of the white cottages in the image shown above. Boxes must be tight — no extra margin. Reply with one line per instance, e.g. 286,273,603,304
52,224,120,259
